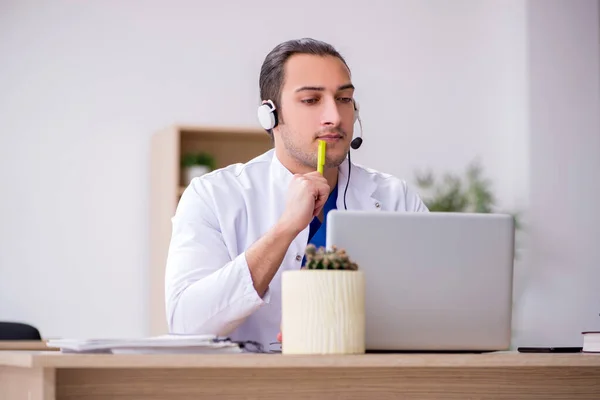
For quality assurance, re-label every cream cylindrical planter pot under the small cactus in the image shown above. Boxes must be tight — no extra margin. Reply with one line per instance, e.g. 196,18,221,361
281,269,365,354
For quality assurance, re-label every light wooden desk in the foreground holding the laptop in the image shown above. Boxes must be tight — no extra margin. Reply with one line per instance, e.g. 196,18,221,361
0,351,600,400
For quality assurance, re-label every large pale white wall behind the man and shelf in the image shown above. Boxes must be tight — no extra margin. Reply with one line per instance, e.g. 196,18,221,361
0,0,528,336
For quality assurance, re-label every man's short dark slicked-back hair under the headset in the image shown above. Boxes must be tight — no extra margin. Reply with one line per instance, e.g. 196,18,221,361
258,38,350,122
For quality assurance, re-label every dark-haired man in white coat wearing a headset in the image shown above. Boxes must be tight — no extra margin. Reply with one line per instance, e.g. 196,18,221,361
166,39,427,348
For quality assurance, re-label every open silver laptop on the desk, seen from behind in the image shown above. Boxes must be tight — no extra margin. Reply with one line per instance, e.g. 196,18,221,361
326,210,514,352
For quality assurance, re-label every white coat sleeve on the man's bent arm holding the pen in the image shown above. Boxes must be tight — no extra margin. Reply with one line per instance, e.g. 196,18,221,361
165,181,270,336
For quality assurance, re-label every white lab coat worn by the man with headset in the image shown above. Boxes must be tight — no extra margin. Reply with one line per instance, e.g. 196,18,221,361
165,149,427,349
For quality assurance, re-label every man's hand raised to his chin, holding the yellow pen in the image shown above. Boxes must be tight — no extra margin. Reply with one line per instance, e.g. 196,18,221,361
280,171,331,233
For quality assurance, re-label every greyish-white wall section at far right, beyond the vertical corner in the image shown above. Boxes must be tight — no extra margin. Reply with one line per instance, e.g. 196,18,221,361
515,0,600,346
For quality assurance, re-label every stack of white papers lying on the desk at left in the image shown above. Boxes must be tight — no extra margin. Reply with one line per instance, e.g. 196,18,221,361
47,335,242,354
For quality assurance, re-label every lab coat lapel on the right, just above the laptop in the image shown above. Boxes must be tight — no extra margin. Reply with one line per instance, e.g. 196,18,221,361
336,158,382,211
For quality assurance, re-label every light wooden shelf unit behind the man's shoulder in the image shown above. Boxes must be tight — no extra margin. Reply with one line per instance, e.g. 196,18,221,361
149,125,273,335
